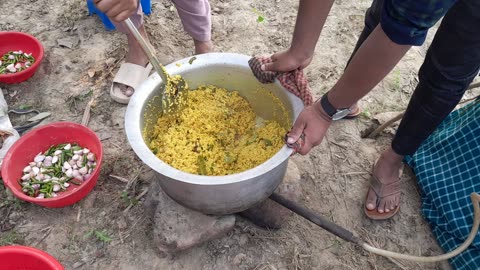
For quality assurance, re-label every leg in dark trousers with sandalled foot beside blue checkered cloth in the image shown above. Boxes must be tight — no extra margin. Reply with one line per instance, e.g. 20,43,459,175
366,1,480,217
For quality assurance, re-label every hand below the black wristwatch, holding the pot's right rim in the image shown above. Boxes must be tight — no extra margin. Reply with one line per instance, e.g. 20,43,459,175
287,102,332,155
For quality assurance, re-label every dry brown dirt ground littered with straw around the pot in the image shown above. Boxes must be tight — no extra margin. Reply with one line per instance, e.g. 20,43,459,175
0,0,478,270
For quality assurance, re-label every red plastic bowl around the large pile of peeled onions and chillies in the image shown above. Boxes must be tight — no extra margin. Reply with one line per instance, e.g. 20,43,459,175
2,122,103,208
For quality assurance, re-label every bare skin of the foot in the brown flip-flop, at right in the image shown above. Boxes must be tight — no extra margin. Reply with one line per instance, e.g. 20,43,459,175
365,147,403,214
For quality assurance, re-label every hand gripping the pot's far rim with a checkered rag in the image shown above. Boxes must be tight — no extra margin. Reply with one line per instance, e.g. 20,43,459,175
262,48,313,72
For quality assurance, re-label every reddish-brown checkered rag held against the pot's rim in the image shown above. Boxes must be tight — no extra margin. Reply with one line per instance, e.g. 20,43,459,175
248,56,313,106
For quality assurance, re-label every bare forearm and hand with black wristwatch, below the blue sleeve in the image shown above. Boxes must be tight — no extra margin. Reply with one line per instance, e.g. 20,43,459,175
287,26,410,155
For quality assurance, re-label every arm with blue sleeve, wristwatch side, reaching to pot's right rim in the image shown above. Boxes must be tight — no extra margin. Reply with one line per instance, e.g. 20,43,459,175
287,0,456,154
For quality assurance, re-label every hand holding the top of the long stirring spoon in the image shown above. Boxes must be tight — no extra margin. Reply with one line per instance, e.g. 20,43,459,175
94,0,138,23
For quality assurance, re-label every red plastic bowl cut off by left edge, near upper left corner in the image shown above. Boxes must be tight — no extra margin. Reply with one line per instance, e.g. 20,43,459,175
0,32,43,83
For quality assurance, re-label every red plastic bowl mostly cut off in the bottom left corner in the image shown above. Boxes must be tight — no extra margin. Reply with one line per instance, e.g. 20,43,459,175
0,246,65,270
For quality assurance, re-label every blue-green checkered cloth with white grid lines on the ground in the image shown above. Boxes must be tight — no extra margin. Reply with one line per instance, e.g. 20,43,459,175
405,99,480,270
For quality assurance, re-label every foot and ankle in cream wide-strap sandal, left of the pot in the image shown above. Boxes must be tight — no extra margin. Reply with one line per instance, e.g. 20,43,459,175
110,25,152,104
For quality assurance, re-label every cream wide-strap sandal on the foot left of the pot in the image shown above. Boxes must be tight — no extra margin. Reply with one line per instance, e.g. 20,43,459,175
110,63,152,104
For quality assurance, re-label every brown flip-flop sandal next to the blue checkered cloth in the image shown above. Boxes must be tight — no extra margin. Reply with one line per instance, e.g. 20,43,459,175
363,163,403,220
